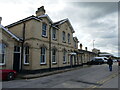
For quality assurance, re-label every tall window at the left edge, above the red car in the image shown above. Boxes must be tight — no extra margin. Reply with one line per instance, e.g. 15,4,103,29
0,44,6,65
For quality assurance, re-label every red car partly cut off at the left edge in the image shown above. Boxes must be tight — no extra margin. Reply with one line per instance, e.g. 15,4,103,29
0,69,16,80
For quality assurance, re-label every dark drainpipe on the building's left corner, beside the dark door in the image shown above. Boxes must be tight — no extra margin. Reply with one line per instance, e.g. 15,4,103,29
21,23,26,71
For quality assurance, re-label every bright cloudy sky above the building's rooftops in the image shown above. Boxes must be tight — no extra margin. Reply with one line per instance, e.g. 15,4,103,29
0,0,118,56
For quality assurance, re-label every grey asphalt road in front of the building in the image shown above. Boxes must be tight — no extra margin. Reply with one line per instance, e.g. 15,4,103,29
2,63,118,88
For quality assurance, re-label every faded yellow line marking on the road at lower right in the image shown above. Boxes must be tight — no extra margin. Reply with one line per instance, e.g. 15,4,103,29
90,73,118,88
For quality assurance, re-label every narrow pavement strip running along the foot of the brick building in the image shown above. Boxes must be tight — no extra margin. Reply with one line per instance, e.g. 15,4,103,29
16,65,90,79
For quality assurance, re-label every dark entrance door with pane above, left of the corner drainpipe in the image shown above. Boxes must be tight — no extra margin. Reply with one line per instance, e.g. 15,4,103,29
13,46,20,72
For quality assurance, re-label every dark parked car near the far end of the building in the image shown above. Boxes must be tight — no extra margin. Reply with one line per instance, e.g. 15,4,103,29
88,57,108,64
